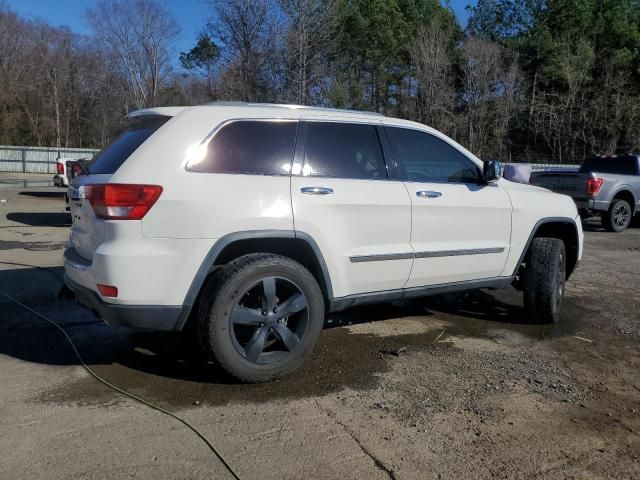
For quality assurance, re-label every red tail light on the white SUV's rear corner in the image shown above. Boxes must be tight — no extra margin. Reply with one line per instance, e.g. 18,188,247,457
84,183,162,220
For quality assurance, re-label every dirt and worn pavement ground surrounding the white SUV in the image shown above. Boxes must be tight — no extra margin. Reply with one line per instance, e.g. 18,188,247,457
0,178,640,480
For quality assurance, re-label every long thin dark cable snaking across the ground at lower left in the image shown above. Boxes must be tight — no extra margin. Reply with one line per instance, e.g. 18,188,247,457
0,262,240,480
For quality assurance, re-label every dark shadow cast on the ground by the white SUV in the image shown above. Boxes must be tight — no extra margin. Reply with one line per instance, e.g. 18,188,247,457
0,262,560,384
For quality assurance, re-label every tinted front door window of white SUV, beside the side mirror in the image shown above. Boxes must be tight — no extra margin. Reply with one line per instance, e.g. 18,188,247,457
387,127,480,182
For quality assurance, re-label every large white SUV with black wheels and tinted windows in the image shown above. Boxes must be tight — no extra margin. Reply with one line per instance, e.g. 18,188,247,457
64,104,583,382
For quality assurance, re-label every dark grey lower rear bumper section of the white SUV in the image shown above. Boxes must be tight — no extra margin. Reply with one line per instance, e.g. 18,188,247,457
64,274,186,331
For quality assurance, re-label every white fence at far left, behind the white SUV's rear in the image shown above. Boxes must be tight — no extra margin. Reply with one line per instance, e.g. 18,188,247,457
0,145,98,173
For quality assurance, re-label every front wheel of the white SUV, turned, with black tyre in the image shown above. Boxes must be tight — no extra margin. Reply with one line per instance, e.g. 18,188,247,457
522,237,566,323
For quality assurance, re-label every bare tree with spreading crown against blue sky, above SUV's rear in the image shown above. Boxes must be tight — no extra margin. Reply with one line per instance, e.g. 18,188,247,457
87,0,180,108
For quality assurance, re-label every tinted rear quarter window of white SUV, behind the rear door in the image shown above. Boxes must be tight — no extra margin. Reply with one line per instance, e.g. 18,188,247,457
189,120,298,175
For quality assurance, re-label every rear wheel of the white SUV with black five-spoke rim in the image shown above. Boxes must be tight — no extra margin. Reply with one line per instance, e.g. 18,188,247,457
198,254,324,383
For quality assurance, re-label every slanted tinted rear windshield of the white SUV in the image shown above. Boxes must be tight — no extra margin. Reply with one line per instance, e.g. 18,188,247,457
88,117,170,174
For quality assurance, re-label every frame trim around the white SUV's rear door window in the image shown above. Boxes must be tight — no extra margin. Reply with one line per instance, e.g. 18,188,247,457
291,117,401,182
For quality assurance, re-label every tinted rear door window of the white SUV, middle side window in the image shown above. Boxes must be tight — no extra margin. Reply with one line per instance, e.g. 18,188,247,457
302,122,387,180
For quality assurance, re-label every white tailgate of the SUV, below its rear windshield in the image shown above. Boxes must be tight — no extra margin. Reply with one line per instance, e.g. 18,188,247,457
69,174,111,260
